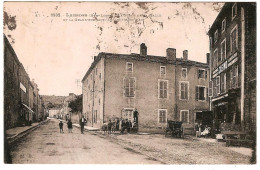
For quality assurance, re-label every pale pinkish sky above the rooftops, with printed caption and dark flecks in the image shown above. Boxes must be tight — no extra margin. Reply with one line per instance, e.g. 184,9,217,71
4,2,223,96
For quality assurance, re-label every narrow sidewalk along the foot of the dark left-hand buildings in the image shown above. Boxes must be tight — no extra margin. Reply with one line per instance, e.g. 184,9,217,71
6,119,49,143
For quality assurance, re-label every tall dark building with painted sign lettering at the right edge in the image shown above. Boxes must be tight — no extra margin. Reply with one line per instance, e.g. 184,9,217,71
208,2,256,131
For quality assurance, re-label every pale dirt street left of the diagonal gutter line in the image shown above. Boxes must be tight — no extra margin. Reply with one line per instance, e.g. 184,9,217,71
11,120,160,164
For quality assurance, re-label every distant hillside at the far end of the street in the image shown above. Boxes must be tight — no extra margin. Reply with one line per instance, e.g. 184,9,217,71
41,95,66,108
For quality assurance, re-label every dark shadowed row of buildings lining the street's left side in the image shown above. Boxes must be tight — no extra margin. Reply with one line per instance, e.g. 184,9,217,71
4,35,43,129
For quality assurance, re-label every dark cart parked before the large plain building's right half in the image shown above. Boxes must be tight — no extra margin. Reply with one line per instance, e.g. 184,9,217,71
165,120,184,138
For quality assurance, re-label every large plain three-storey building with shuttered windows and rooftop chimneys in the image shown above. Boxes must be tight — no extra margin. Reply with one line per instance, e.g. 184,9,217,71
82,44,209,132
